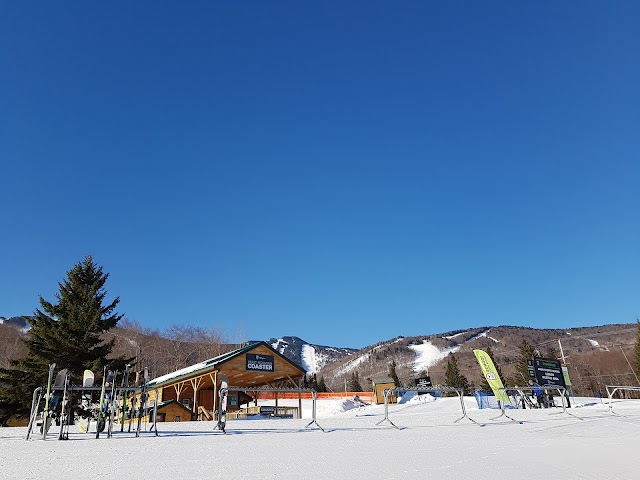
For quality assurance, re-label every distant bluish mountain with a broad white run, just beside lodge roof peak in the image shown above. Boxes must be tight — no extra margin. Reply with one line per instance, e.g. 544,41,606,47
267,337,357,375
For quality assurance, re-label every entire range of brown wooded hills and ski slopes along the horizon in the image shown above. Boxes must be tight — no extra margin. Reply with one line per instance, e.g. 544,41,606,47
0,319,639,395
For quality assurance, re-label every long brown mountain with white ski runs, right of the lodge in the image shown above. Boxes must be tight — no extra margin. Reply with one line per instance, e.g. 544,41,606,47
318,324,638,394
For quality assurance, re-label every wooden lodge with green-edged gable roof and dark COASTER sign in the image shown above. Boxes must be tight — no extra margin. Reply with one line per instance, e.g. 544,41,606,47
148,342,306,422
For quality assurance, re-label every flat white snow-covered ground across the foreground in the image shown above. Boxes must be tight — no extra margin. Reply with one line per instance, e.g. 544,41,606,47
0,397,640,480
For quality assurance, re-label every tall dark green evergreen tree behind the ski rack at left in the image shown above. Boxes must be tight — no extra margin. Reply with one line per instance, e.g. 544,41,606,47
0,256,128,420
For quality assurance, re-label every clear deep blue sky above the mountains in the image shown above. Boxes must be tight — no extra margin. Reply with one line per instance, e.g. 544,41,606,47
0,1,640,347
